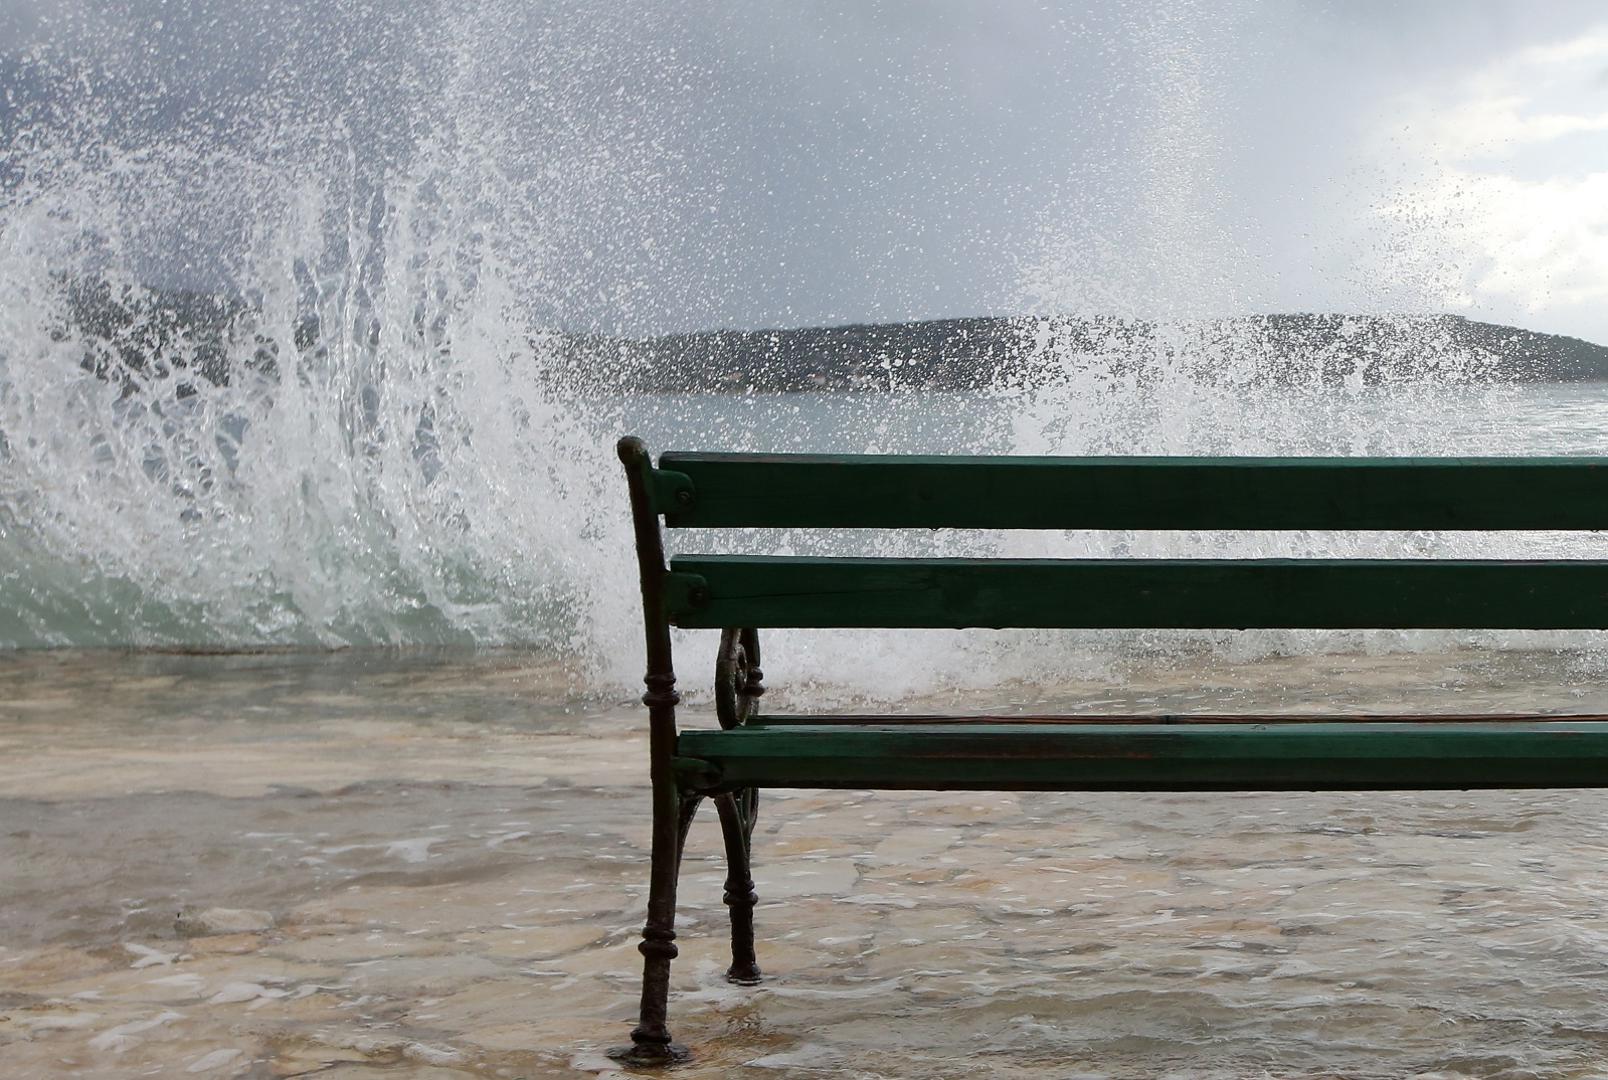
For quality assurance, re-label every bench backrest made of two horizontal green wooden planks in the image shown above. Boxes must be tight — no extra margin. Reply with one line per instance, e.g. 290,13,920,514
630,453,1608,630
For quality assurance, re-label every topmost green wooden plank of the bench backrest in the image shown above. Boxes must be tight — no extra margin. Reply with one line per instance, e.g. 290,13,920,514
658,453,1608,530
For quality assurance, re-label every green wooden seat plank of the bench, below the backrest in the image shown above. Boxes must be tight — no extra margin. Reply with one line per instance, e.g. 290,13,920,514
677,720,1608,791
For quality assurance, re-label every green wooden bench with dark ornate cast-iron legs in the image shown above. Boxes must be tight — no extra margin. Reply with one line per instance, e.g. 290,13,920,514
616,439,1608,1064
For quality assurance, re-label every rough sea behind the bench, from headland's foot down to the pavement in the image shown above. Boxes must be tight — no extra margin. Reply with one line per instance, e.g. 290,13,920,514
9,379,1608,701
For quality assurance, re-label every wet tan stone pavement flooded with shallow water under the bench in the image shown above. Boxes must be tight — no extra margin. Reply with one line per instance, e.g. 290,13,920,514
0,651,1608,1080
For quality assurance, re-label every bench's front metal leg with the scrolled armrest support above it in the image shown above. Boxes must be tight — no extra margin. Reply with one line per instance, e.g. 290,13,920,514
714,627,765,987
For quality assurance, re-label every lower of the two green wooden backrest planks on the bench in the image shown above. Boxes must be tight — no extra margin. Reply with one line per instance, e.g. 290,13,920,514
666,554,1608,630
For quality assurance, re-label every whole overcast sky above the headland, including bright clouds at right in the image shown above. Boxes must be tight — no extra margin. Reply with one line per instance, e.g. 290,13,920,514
0,0,1608,342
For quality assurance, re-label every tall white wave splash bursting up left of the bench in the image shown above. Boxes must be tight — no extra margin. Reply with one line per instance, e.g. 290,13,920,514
0,2,659,653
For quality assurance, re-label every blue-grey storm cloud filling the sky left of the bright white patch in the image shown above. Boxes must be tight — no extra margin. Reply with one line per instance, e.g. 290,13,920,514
9,0,1608,336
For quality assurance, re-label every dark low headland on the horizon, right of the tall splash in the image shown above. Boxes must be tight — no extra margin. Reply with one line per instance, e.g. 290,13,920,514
561,313,1608,392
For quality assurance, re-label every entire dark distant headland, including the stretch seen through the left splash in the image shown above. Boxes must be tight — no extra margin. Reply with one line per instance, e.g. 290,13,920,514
56,283,1608,394
